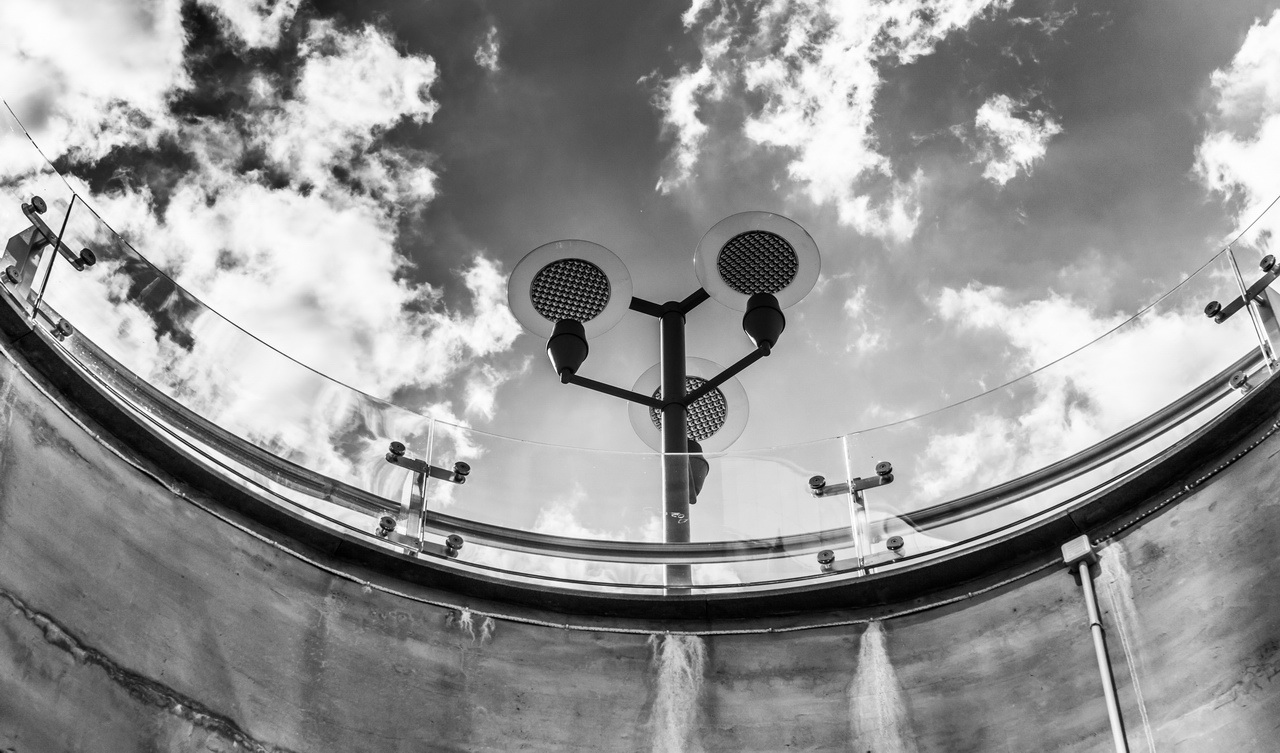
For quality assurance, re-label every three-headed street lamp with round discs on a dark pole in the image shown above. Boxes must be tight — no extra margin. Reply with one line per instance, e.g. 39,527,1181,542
508,211,820,588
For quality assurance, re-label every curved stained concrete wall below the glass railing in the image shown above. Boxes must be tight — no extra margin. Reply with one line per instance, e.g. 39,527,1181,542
0,343,1280,753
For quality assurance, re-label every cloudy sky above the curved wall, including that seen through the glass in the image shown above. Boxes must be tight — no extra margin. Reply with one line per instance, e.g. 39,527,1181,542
0,0,1280,558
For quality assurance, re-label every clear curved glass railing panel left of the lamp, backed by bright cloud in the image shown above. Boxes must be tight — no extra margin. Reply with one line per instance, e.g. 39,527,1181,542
27,180,431,519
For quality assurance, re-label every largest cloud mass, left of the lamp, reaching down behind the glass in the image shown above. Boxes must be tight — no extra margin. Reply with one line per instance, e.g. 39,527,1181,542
5,8,520,496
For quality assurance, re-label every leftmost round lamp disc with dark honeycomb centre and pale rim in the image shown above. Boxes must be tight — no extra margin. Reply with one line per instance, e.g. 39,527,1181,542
507,241,631,338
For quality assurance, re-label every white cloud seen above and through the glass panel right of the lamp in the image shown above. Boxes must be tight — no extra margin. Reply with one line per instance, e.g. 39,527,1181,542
904,281,1256,507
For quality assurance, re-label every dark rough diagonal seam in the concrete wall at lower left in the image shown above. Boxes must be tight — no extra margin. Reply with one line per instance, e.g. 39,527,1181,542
0,589,292,753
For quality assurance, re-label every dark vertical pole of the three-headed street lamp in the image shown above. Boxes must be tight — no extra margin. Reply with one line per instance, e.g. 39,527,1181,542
660,306,692,593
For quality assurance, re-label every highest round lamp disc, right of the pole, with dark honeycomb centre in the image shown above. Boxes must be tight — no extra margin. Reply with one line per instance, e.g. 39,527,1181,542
694,211,822,311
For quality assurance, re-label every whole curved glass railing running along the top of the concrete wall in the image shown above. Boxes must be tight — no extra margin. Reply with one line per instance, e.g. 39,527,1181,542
0,105,1266,593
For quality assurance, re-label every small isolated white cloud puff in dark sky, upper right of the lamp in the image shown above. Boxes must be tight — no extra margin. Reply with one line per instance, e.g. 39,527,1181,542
974,95,1062,186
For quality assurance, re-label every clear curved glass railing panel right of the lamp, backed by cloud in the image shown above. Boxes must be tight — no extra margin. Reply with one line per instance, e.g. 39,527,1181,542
841,249,1257,562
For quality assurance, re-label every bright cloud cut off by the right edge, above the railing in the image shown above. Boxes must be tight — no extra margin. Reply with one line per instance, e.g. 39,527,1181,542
1196,10,1280,244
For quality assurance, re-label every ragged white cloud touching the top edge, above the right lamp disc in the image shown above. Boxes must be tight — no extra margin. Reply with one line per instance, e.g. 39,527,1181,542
657,0,1009,241
